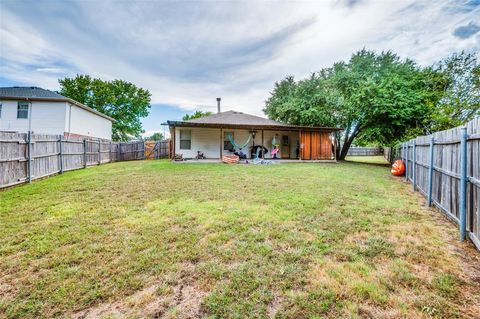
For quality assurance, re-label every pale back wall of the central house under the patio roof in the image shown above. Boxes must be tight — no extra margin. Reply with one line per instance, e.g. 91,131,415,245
175,127,298,158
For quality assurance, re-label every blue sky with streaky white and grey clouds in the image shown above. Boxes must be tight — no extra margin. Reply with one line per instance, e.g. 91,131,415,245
0,0,480,130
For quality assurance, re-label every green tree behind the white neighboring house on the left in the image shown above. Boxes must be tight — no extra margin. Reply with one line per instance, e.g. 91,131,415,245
58,74,151,141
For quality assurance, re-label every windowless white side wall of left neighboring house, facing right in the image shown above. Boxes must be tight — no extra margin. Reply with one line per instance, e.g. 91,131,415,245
65,103,112,140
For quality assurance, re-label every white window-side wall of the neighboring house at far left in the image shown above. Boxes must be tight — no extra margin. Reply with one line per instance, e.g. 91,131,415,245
0,101,66,134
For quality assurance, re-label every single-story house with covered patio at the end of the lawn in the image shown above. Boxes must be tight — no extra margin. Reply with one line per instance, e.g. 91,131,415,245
167,99,340,161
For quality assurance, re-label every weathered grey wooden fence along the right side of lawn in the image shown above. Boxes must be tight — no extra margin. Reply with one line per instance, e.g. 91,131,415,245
400,118,480,250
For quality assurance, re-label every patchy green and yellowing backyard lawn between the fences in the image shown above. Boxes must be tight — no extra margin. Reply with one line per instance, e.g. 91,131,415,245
0,159,480,318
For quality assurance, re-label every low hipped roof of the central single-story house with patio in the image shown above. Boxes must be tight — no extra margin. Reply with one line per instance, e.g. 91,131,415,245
168,111,340,130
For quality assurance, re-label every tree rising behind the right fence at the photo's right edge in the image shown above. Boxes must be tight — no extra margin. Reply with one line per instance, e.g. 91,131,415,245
431,51,480,132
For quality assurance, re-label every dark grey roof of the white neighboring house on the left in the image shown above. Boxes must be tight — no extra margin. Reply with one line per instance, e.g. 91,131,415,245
0,86,115,121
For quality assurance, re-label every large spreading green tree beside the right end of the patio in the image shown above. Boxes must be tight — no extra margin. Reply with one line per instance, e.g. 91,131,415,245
264,49,443,160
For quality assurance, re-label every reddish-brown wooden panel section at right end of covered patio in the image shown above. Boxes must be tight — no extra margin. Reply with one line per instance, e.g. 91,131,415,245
300,132,333,160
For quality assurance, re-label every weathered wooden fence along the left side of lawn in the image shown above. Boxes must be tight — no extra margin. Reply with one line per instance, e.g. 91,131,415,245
0,132,145,188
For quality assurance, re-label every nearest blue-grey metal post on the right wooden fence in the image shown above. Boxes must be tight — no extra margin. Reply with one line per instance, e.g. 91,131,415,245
460,127,467,241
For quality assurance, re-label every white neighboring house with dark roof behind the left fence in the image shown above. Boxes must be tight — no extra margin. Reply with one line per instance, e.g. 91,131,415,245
0,86,114,140
